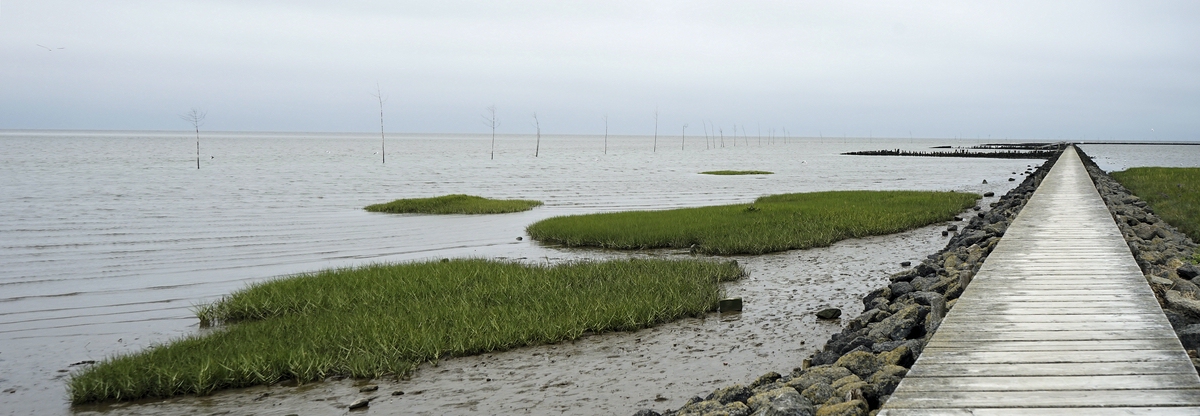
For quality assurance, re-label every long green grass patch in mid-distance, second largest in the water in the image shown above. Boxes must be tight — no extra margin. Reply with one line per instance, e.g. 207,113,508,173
526,191,979,255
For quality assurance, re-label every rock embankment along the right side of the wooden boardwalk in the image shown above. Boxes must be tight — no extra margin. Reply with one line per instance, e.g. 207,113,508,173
1079,151,1200,369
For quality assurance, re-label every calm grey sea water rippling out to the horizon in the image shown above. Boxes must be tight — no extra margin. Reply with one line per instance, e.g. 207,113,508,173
0,132,1200,414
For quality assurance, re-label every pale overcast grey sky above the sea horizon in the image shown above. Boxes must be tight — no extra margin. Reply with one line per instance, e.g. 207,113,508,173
0,0,1200,140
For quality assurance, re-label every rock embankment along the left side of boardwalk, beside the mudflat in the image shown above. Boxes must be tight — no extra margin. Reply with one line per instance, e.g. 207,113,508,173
635,151,1065,416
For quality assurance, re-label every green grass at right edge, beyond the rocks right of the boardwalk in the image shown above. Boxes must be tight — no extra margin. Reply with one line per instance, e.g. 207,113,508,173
1111,168,1200,241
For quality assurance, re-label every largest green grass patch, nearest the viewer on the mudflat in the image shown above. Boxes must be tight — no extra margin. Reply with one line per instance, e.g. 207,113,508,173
68,260,744,404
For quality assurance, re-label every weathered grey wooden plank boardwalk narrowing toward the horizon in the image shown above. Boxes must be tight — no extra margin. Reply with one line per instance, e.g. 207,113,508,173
880,149,1200,416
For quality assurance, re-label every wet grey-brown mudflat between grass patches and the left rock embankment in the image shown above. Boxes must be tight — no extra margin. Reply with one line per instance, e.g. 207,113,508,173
73,214,969,415
